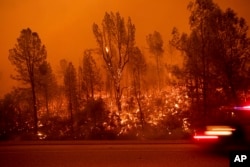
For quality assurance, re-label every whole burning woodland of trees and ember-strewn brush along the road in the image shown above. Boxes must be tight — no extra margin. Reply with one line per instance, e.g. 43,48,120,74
0,0,250,139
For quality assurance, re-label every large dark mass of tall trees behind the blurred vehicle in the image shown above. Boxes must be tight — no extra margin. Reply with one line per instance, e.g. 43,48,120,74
170,0,250,122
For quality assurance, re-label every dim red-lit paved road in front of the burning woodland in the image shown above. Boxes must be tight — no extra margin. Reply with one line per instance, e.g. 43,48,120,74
0,142,229,167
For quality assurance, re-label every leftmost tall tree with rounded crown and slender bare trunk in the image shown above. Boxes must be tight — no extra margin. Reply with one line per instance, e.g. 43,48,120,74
9,28,47,134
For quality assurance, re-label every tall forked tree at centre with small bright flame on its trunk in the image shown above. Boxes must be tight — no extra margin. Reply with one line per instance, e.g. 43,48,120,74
93,12,135,112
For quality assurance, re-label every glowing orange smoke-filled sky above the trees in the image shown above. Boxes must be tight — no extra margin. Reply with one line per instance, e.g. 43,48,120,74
0,0,250,98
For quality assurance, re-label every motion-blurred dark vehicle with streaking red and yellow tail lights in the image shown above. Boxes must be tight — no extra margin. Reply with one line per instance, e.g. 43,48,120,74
193,105,250,148
